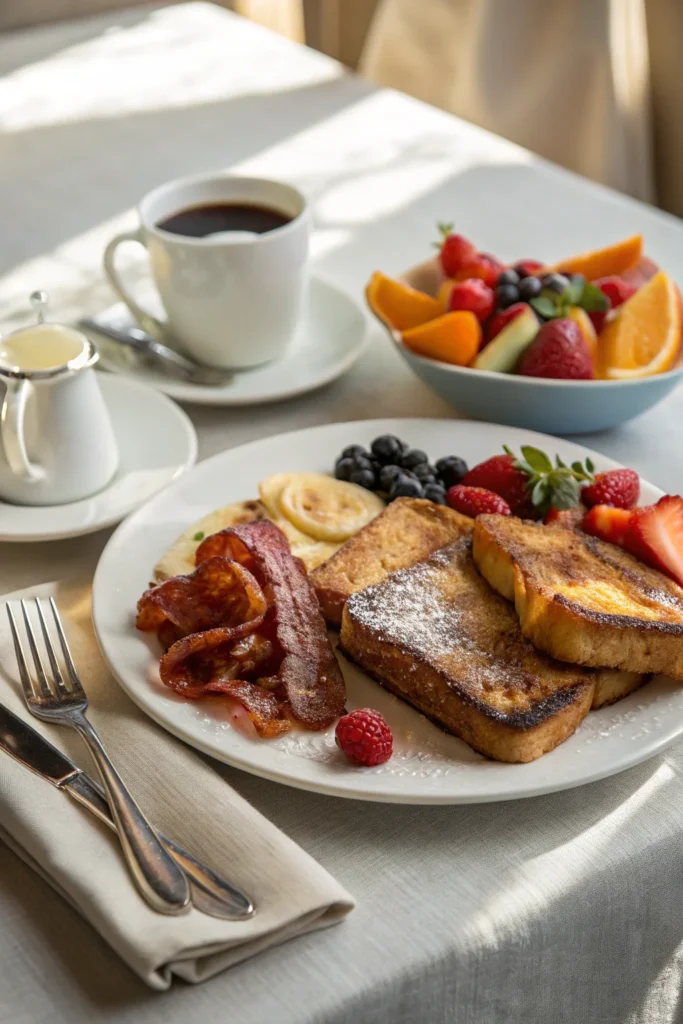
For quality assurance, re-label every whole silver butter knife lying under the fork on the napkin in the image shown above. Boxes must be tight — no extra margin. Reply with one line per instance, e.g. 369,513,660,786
0,703,254,921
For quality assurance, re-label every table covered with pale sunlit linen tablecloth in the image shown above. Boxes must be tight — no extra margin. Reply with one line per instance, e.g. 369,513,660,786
0,2,683,1024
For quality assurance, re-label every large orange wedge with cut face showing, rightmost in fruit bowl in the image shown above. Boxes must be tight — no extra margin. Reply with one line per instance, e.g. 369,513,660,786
598,270,681,380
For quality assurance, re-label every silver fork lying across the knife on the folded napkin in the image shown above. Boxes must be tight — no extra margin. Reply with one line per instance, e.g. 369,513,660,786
6,598,189,913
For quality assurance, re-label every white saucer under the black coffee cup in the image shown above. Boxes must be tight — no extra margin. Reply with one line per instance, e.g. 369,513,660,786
92,278,366,406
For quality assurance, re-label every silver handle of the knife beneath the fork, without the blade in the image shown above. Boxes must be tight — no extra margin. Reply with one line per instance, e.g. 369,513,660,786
61,772,254,921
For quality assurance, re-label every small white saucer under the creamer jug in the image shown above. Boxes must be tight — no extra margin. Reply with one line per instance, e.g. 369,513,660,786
0,374,197,542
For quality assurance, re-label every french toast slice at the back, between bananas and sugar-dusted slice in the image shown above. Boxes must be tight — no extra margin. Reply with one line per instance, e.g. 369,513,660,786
310,498,472,626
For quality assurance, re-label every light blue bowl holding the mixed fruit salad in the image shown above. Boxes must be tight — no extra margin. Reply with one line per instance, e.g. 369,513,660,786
380,261,683,434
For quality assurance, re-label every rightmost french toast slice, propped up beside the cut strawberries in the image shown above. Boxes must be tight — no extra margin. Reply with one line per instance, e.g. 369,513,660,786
473,515,683,688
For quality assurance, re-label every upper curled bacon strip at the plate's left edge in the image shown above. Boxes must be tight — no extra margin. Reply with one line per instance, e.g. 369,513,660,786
136,558,266,646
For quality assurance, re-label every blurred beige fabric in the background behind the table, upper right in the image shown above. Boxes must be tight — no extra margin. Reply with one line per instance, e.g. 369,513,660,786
360,0,683,215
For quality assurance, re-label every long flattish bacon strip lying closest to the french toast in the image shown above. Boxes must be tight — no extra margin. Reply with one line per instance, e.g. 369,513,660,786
197,520,346,729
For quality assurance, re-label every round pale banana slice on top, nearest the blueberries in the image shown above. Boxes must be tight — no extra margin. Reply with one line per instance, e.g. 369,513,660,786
276,473,384,541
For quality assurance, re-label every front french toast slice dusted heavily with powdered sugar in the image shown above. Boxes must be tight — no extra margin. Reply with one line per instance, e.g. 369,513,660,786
340,536,595,762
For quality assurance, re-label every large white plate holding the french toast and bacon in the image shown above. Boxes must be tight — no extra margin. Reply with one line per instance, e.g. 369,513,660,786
93,420,683,804
